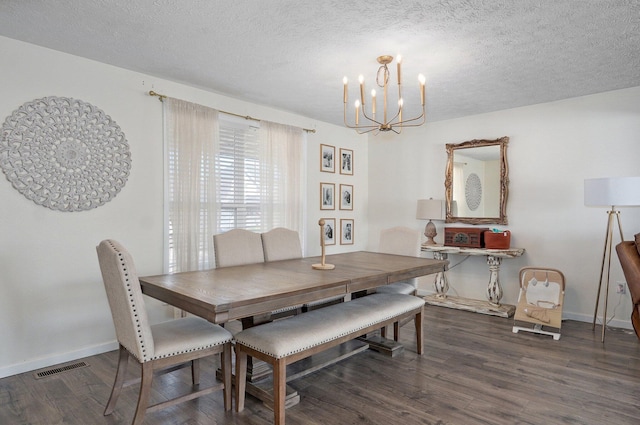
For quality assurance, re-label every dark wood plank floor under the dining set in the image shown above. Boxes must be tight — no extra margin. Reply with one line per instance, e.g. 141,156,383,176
0,306,640,425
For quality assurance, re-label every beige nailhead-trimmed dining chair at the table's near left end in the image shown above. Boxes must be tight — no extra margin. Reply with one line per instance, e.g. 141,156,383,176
96,239,233,425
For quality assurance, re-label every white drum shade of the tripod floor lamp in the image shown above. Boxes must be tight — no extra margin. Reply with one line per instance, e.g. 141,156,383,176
584,177,640,207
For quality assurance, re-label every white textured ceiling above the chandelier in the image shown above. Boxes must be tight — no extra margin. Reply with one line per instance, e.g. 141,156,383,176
0,0,640,124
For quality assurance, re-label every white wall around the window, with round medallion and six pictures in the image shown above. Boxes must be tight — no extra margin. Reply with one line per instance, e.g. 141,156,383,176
0,37,368,377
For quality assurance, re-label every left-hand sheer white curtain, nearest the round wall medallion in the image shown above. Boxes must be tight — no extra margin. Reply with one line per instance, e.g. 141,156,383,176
164,98,220,272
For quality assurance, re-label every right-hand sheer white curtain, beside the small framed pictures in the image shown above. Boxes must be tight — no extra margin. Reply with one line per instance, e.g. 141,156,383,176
259,121,305,236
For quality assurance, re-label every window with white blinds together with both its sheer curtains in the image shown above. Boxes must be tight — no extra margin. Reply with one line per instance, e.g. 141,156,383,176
164,98,306,272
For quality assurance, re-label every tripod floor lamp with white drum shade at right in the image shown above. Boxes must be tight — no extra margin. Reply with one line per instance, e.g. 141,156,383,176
584,177,640,342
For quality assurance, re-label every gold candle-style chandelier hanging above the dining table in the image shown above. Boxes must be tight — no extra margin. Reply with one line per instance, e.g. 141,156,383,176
342,55,426,134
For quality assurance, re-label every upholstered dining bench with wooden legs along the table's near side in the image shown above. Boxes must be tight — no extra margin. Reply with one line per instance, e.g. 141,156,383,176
234,294,424,425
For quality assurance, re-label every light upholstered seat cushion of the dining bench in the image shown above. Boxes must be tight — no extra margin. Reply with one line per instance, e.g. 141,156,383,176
234,294,424,359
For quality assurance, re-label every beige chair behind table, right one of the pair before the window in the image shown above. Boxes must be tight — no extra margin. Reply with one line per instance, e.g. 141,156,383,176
262,227,344,312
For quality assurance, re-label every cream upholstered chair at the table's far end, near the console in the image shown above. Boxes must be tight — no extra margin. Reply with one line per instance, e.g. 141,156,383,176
376,226,422,341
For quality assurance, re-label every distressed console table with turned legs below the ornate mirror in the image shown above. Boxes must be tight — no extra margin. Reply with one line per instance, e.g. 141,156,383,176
422,245,525,317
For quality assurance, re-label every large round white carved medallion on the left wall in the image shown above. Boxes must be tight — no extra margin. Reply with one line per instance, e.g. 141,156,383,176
0,96,131,211
